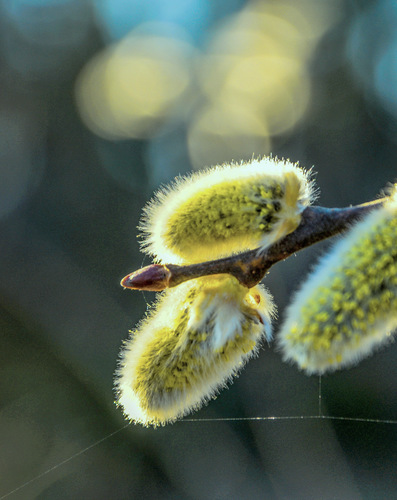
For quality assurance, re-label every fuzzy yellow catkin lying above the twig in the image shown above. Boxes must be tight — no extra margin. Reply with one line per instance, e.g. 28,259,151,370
140,158,313,264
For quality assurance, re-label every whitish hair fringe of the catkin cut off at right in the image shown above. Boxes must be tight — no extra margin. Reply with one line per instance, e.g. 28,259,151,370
276,189,397,375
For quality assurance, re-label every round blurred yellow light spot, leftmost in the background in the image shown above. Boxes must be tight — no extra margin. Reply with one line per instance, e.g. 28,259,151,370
76,24,194,139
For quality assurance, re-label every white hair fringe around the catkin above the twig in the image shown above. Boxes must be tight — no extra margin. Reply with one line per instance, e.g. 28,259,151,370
138,157,317,264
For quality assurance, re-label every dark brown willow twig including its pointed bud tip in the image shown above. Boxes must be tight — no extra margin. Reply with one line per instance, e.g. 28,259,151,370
121,198,387,291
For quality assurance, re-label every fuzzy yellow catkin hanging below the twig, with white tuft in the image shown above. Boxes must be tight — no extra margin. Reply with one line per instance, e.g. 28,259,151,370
115,275,273,426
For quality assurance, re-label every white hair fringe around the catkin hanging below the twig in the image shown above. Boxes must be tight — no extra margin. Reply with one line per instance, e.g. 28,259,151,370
115,280,274,426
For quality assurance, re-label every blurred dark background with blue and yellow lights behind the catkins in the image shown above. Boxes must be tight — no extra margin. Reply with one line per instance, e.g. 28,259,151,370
0,0,397,500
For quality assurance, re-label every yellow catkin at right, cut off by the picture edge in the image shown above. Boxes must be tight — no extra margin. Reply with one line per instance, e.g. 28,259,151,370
278,188,397,374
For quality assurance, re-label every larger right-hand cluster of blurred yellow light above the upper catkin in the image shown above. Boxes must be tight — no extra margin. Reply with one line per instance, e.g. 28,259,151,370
189,0,336,167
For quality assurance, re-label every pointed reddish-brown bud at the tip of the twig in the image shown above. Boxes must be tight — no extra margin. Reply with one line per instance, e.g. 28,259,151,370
120,264,171,292
